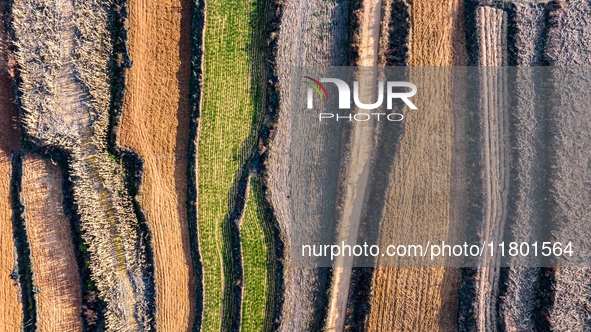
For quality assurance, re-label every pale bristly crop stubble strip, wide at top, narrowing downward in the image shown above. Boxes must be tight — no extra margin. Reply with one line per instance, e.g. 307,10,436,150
10,0,152,331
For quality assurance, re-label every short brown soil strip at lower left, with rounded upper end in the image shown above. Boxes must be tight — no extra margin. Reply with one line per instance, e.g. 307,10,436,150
21,154,82,331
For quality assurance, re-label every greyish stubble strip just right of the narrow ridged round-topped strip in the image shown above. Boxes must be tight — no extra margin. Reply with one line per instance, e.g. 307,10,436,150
498,3,546,331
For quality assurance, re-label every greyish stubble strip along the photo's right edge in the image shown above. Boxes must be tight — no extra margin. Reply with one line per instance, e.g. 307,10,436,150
544,1,591,331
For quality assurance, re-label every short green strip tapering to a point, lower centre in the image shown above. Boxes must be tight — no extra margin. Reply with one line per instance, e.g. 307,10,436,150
240,175,273,331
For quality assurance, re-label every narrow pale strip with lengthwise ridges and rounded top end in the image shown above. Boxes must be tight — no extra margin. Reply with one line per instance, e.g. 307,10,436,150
475,7,509,331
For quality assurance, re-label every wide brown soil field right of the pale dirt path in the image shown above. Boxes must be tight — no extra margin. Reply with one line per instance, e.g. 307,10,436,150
367,0,467,331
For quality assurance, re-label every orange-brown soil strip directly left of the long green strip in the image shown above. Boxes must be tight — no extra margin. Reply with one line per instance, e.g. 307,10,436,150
118,0,196,332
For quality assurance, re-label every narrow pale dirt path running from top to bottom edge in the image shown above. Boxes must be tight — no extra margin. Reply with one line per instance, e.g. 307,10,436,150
326,0,382,331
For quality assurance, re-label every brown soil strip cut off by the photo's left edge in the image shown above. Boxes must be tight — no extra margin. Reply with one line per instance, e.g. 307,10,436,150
0,1,23,331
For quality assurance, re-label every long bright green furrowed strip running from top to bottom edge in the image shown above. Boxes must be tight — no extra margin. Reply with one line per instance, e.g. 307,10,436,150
196,0,268,331
